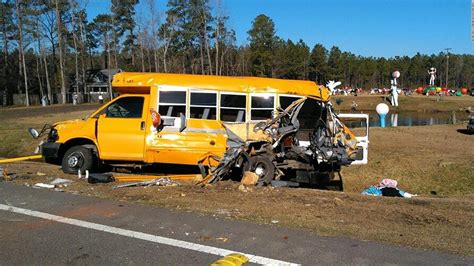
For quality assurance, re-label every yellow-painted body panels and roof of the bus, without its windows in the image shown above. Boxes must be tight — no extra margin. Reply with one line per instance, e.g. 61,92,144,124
48,73,329,166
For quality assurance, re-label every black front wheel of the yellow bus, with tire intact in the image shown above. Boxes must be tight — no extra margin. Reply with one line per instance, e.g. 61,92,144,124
61,146,95,174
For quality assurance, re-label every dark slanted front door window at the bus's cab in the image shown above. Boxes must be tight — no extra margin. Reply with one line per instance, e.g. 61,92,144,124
105,97,143,118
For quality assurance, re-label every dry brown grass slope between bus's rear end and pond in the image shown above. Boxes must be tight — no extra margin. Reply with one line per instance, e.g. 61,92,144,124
342,125,474,196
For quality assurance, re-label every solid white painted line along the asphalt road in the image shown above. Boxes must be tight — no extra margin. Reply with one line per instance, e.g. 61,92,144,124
0,204,298,265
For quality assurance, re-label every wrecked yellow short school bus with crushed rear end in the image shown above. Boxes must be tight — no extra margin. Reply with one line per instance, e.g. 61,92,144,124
33,73,368,185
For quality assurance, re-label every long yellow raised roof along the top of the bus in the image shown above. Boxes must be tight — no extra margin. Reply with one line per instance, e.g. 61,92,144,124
112,72,330,101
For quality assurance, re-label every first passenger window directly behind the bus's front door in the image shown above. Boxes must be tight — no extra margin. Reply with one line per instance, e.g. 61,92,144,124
158,90,186,117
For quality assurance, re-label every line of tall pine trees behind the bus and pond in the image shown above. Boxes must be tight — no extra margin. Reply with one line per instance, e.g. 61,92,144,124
0,0,474,105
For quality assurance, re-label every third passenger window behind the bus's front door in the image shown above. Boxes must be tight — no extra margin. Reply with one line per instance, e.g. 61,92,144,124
220,93,247,123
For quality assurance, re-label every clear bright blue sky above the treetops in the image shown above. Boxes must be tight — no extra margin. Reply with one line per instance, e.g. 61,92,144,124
87,0,474,57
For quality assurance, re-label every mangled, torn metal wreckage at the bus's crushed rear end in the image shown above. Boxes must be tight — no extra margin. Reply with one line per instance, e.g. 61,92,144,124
199,98,362,188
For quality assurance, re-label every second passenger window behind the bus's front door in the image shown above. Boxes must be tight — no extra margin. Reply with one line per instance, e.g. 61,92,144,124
189,91,217,120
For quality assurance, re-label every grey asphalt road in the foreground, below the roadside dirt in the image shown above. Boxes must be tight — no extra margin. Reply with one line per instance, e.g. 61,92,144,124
0,183,474,265
